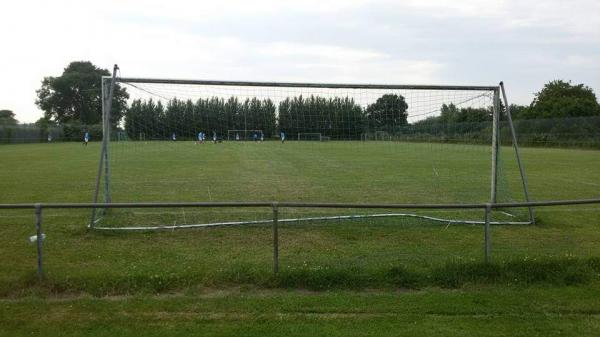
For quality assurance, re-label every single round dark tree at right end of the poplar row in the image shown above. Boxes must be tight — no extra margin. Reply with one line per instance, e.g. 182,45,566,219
366,94,408,131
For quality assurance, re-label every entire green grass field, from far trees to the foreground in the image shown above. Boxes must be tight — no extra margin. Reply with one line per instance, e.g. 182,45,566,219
0,142,600,336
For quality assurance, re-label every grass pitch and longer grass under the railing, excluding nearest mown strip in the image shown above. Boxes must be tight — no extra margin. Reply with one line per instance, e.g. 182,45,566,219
0,142,600,294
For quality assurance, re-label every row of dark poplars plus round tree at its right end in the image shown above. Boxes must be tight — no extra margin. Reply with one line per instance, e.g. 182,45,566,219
125,95,408,140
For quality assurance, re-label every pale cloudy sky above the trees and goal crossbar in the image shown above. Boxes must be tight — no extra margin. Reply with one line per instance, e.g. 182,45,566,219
0,0,600,122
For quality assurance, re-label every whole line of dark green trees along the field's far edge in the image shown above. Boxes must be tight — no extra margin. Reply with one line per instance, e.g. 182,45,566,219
0,61,600,144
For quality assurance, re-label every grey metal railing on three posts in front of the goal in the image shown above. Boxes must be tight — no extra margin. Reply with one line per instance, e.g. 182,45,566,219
0,198,600,280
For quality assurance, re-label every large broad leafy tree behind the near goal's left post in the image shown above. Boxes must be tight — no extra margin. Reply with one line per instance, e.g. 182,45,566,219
36,61,129,126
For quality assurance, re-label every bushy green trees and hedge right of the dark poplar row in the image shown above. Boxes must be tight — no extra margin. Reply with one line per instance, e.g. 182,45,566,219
399,80,600,147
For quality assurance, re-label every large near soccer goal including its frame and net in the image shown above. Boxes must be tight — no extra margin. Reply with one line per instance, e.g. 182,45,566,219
89,65,535,229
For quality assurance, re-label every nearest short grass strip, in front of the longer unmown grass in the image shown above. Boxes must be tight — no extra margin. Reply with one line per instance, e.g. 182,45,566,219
0,285,600,336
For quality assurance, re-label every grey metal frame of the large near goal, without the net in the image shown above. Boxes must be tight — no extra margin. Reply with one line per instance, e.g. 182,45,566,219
88,65,535,229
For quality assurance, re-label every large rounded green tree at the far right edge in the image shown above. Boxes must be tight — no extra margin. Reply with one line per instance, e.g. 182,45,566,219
523,80,600,119
